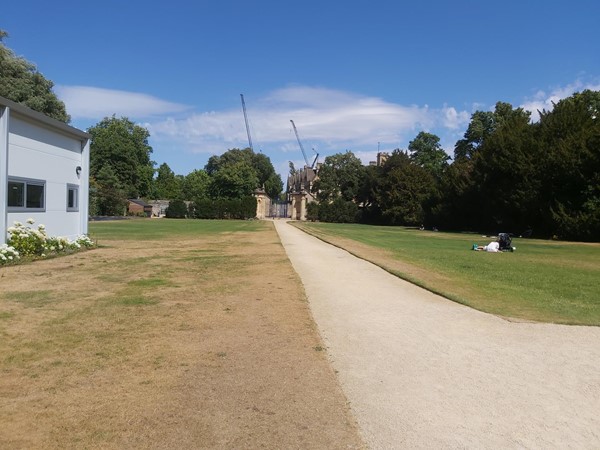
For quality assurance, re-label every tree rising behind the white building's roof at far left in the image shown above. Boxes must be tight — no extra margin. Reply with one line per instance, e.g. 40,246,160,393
0,30,71,123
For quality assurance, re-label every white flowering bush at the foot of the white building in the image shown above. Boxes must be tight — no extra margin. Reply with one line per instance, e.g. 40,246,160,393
0,219,96,265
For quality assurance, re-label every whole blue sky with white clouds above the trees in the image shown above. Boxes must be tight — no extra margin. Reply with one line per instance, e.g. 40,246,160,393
0,0,600,181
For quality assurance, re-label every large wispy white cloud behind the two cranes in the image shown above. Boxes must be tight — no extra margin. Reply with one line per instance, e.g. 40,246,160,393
146,86,470,154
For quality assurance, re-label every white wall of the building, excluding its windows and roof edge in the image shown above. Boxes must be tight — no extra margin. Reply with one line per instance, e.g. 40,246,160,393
2,112,89,242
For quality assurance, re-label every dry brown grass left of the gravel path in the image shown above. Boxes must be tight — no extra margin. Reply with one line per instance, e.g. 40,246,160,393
0,223,362,449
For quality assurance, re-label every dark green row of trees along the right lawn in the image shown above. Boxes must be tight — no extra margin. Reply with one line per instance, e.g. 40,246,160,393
310,90,600,241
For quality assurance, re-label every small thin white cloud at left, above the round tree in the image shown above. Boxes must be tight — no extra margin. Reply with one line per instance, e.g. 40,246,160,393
55,86,190,120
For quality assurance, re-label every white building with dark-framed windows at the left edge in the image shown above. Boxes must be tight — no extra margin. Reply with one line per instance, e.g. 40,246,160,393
0,97,90,244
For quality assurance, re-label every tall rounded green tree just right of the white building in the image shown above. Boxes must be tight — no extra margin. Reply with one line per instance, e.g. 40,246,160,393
88,116,154,197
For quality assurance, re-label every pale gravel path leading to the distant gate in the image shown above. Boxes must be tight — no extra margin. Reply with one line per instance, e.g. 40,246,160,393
275,221,600,449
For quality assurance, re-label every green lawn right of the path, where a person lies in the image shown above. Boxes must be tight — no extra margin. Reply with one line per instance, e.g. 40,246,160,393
292,223,600,325
